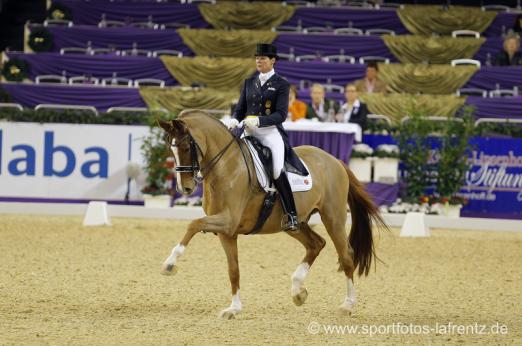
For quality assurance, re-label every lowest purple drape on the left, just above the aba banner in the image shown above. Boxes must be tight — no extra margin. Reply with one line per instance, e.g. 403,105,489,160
0,83,147,111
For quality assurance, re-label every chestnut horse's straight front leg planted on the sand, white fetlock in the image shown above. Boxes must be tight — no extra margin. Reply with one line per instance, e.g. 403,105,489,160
215,234,242,320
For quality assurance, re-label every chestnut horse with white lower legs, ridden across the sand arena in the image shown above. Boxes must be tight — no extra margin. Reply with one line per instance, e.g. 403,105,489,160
159,110,386,319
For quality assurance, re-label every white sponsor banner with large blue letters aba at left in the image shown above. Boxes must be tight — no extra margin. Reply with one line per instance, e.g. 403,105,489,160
0,122,149,201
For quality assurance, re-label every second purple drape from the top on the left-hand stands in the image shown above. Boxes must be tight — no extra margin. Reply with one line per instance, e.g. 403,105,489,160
39,26,193,55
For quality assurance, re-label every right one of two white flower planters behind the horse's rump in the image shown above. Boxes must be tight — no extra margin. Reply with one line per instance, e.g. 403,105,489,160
373,144,399,184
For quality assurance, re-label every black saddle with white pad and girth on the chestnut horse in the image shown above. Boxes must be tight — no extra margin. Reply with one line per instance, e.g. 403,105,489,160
242,136,312,234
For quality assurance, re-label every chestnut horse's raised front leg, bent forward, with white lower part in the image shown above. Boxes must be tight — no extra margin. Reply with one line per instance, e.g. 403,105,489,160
161,214,230,275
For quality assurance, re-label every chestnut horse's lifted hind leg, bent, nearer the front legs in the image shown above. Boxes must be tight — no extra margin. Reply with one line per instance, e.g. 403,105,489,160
288,223,326,306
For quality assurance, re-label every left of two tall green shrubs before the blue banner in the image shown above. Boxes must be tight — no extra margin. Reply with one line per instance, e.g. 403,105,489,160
395,104,435,202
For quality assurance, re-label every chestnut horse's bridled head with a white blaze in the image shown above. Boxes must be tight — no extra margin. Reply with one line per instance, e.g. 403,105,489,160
158,120,200,195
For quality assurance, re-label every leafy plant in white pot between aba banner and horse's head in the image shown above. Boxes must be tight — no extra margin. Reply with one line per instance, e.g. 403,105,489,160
141,116,174,208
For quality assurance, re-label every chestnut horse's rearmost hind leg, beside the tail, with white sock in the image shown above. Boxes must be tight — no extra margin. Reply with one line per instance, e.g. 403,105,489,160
321,211,356,312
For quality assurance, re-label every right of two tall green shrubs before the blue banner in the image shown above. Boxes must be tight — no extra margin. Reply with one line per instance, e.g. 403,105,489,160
436,107,474,203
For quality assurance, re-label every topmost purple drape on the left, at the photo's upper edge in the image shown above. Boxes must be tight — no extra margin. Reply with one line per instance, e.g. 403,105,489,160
54,0,205,28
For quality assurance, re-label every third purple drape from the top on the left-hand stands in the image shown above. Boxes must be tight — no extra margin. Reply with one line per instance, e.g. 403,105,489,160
8,53,177,85
